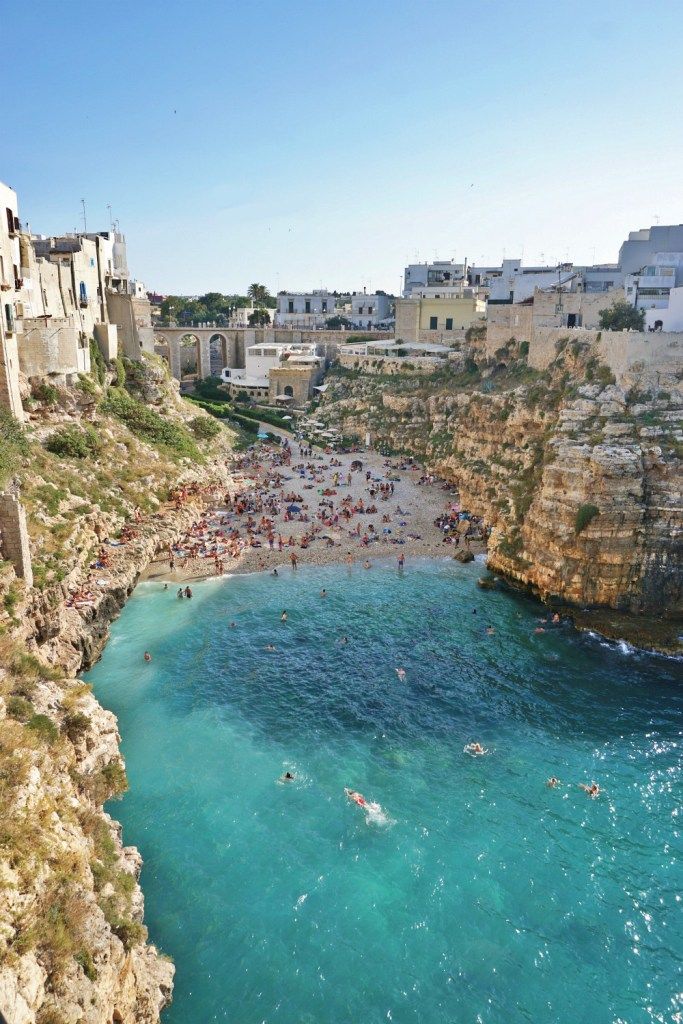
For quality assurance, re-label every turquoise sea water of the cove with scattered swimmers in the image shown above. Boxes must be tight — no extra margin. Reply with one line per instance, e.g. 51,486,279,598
87,561,683,1024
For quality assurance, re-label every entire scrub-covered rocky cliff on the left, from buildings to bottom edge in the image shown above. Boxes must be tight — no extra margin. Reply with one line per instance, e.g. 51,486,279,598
0,360,240,1024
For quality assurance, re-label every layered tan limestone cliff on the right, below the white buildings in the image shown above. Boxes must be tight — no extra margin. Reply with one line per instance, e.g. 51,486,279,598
321,353,683,615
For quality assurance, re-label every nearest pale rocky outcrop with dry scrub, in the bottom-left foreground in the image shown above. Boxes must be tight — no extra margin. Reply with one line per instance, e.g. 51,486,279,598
0,670,174,1024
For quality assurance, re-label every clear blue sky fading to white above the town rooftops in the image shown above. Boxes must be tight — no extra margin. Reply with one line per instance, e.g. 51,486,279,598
5,0,683,294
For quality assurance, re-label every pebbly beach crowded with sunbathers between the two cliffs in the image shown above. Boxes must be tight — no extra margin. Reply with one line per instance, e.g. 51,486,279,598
142,441,485,584
